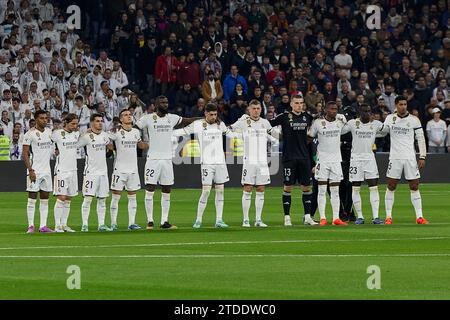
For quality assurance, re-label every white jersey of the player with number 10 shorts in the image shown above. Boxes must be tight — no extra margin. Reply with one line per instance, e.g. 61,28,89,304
52,129,80,174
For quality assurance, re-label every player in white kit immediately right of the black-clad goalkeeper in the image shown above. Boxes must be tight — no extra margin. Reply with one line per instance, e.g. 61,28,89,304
308,101,347,226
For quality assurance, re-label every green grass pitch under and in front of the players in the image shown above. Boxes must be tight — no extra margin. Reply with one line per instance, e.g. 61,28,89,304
0,185,450,299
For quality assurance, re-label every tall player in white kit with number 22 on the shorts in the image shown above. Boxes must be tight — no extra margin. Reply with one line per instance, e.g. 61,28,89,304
136,96,200,230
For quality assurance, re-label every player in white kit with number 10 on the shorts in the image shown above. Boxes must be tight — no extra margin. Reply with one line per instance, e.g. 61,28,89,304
52,113,80,232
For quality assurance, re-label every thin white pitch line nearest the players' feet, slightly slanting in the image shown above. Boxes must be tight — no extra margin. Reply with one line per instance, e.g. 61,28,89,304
0,237,450,251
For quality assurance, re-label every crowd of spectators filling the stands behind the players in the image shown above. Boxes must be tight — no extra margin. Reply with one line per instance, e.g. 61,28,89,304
0,0,450,160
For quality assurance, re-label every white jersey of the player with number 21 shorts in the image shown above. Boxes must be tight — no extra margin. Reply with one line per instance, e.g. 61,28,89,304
78,131,111,176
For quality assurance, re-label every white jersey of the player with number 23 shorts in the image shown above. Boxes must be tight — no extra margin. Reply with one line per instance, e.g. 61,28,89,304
344,119,383,161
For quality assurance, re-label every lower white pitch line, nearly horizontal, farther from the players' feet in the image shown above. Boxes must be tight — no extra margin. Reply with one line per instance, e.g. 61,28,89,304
0,253,450,259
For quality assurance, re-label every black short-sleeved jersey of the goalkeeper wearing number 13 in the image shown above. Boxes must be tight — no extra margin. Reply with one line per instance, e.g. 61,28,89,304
269,112,313,161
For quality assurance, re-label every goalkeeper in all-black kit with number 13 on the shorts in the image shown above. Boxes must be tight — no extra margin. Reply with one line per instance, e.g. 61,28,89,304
269,95,317,226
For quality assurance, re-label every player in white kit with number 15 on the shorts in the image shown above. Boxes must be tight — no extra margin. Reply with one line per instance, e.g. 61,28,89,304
173,103,230,229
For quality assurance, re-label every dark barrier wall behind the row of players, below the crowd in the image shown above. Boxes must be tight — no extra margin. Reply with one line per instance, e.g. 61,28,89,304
0,154,450,192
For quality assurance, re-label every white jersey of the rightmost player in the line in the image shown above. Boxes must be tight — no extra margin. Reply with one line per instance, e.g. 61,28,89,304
382,113,426,161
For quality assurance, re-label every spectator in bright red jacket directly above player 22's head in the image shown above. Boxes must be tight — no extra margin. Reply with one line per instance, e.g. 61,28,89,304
155,46,179,94
